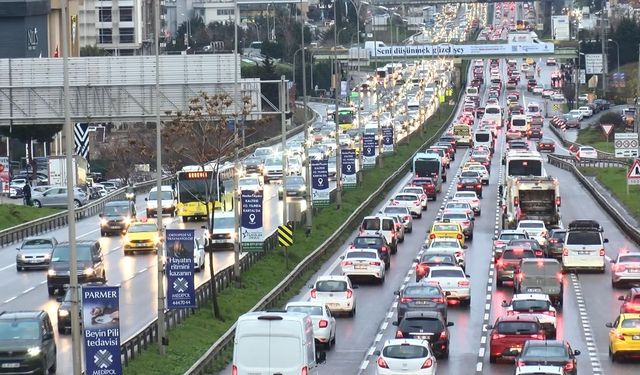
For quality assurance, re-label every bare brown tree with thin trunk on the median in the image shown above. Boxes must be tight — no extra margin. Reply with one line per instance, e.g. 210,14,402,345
162,92,251,320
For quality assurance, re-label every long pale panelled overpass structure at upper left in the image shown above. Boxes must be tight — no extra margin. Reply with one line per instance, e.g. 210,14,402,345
0,54,262,126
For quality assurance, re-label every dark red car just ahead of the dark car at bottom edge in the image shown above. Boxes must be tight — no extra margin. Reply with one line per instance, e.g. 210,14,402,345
487,314,546,363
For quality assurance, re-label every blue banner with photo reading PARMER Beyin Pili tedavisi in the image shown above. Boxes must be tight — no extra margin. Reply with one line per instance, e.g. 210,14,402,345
80,285,122,375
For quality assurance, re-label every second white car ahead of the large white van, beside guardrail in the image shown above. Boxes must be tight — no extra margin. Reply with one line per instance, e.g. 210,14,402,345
309,275,356,316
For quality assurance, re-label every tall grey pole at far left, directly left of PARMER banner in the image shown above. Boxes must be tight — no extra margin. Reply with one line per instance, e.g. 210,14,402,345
61,0,82,375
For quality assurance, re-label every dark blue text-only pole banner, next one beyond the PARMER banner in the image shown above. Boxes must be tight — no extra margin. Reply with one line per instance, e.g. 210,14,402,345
166,229,197,309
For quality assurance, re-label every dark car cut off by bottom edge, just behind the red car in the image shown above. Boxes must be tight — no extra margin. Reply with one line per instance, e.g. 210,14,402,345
516,340,580,375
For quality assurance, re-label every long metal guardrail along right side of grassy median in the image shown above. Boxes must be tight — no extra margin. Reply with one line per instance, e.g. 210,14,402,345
185,84,464,375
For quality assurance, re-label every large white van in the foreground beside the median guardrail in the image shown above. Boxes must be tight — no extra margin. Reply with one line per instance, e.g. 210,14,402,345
231,311,324,375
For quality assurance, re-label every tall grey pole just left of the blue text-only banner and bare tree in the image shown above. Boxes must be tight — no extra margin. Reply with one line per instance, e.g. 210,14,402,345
154,0,168,355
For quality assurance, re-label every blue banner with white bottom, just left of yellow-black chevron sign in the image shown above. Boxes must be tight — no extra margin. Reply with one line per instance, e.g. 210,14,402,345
240,190,264,251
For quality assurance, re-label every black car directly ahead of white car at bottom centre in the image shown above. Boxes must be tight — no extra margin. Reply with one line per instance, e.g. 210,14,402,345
393,311,453,358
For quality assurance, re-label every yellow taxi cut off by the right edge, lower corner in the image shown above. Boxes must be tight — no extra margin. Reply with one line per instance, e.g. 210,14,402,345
606,314,640,361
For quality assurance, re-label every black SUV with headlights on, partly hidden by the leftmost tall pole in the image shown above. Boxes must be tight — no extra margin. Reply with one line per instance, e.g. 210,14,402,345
47,240,107,296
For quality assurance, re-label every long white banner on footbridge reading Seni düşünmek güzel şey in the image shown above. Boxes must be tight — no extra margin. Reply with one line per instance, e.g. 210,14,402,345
372,42,554,57
